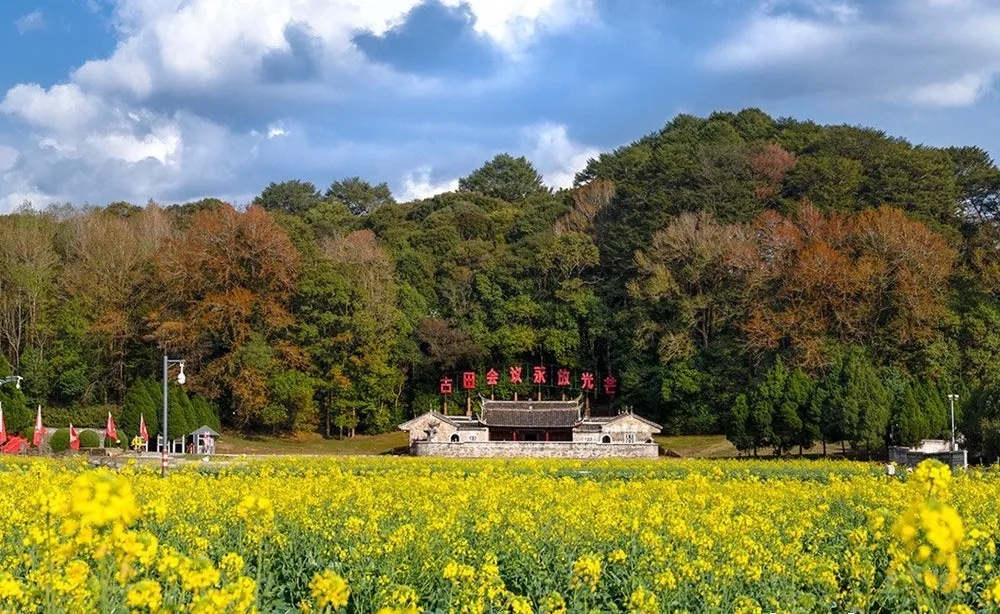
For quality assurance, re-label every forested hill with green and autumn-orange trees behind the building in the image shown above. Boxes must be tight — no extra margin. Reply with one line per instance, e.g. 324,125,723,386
0,109,1000,456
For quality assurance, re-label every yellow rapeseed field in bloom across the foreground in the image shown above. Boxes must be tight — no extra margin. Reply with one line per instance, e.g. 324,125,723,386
0,458,1000,614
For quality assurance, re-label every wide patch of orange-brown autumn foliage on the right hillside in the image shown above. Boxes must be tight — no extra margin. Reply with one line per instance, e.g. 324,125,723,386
729,204,957,372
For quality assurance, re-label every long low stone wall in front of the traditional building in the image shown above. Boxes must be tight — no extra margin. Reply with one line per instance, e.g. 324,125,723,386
410,441,659,458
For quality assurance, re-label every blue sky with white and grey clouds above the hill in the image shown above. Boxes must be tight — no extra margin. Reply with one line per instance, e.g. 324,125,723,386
0,0,1000,213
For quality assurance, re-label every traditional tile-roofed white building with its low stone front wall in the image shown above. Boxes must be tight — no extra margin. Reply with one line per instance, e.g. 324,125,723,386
399,399,662,458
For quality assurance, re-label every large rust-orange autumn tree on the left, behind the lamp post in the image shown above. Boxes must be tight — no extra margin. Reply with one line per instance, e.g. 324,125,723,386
149,206,299,427
